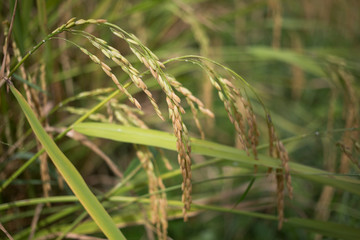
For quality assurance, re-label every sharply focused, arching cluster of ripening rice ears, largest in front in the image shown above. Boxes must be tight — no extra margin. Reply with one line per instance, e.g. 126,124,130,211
53,19,213,229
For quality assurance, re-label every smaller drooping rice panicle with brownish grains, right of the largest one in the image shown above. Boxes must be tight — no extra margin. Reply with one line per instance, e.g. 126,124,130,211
165,55,293,228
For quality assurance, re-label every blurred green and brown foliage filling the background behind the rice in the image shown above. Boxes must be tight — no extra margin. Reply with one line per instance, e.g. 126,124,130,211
0,0,360,239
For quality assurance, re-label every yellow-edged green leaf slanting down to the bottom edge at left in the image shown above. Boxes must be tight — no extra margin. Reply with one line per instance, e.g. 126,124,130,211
10,86,125,240
